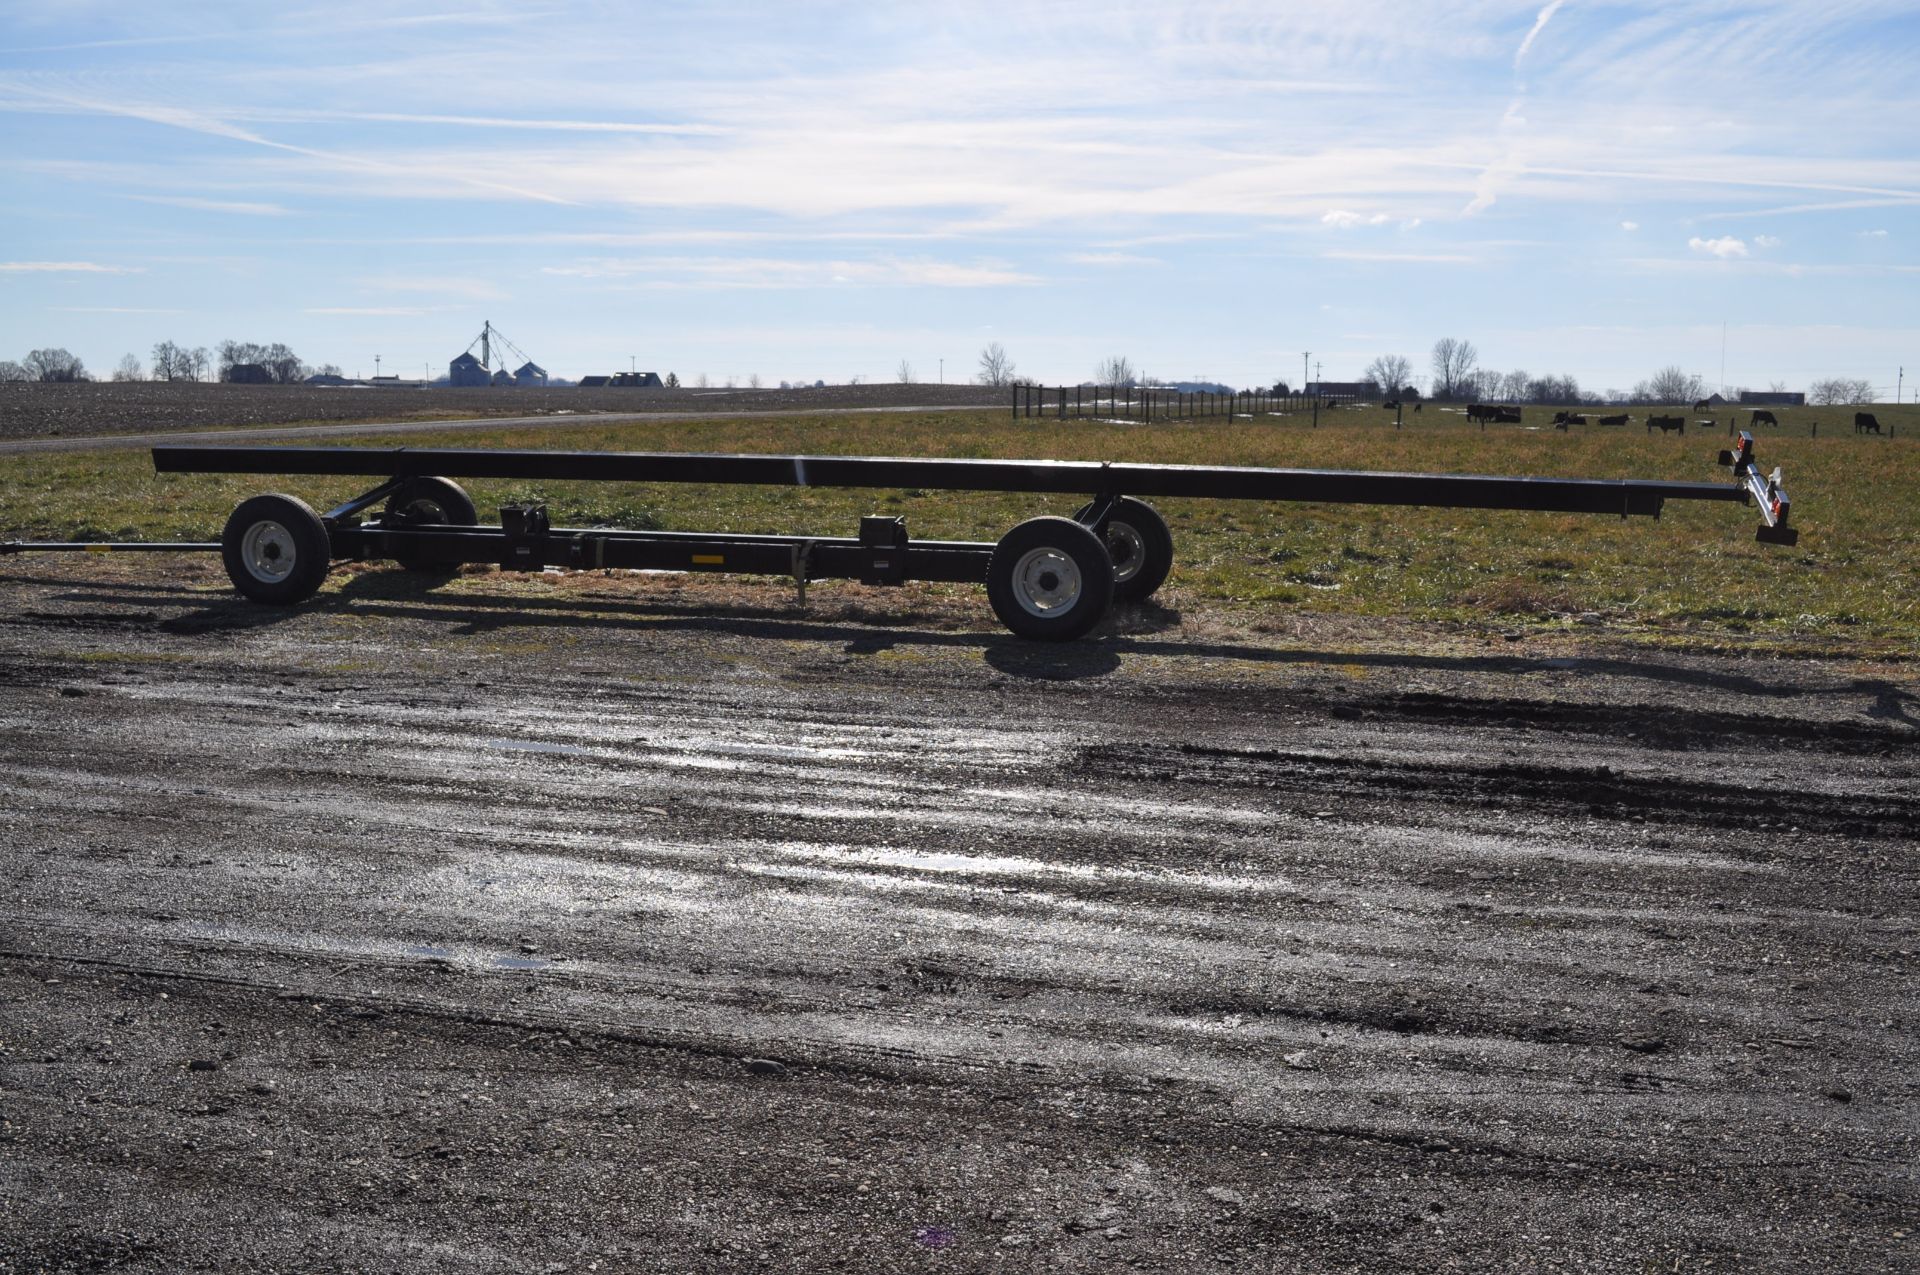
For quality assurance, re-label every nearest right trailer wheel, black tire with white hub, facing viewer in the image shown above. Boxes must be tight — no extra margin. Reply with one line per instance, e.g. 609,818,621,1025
987,518,1114,641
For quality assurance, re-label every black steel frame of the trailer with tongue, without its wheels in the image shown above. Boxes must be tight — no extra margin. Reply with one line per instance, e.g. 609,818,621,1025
0,432,1799,586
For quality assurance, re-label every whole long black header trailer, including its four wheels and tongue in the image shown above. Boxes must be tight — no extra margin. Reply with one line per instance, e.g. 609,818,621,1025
0,434,1797,639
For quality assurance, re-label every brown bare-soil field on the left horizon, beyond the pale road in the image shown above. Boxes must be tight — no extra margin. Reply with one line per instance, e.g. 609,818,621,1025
0,380,1008,444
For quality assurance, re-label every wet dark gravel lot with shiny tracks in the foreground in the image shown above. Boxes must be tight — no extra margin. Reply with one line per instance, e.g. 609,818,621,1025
0,561,1920,1271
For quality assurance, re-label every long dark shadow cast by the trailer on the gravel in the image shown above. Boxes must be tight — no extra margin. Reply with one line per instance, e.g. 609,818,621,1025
18,572,1920,730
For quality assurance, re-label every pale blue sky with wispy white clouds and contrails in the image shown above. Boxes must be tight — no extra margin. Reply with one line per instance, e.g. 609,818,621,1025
0,0,1920,397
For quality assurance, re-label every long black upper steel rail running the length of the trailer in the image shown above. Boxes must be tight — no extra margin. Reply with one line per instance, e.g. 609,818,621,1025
154,440,1751,517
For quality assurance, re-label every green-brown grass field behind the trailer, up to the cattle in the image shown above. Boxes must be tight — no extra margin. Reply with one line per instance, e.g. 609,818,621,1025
0,407,1920,659
